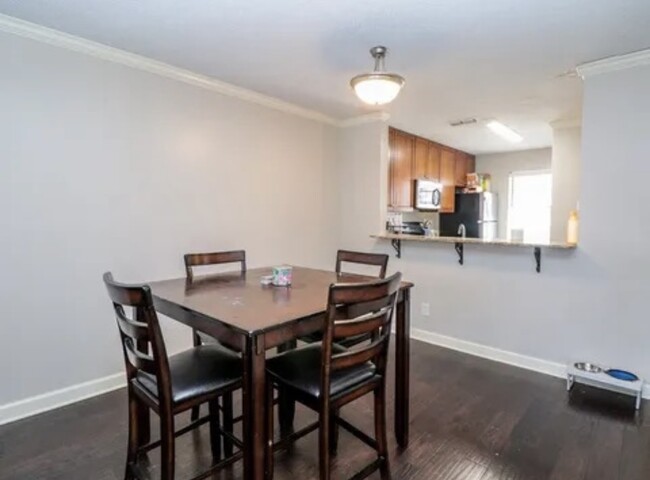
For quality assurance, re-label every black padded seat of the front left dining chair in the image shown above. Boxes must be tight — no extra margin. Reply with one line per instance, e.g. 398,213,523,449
134,345,242,403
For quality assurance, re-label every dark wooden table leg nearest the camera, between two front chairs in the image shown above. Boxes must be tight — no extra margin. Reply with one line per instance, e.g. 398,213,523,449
242,335,266,480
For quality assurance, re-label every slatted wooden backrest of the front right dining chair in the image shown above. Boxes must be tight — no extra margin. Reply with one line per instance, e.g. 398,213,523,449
321,273,402,398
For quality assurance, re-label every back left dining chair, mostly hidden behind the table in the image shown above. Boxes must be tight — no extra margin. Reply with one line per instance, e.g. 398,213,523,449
183,250,246,430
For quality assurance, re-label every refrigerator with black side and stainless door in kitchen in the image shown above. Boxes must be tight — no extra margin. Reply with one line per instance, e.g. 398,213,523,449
440,192,497,240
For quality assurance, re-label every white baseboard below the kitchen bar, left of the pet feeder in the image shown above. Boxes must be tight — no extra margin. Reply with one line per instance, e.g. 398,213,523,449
411,328,650,399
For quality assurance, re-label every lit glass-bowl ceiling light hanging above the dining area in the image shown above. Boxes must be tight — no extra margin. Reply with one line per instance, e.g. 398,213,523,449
350,46,404,105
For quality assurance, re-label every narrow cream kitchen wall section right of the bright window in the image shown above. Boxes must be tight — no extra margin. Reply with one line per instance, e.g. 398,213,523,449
551,126,583,242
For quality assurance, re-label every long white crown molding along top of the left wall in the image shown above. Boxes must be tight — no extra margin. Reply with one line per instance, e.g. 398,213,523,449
0,14,340,126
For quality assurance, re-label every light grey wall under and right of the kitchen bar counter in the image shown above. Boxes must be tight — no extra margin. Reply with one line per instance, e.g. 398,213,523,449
340,62,650,394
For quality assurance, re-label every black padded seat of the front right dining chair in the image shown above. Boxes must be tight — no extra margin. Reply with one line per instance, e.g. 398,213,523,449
266,343,376,398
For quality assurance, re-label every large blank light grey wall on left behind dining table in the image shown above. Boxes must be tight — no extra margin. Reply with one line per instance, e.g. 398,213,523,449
0,33,336,406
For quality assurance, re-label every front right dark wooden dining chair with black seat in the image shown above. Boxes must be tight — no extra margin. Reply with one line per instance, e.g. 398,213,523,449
266,273,402,480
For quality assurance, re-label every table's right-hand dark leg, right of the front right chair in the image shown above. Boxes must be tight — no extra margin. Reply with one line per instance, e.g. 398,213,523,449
395,289,411,448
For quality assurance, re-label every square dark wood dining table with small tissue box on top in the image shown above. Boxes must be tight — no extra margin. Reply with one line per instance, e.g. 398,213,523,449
149,267,413,480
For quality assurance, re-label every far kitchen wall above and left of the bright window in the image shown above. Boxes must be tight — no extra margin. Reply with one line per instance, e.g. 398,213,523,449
476,148,551,238
